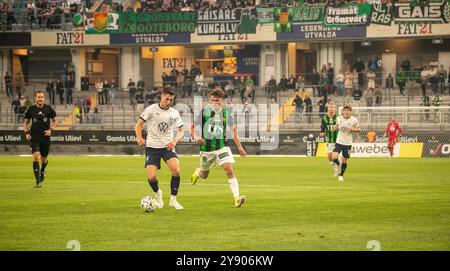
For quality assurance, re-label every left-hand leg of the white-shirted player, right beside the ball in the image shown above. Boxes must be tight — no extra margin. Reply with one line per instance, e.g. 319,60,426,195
145,148,164,208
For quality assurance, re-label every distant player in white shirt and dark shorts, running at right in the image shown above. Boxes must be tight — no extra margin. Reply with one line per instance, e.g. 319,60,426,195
332,105,361,182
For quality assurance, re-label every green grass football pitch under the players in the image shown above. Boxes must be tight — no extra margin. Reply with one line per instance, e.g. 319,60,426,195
0,156,450,251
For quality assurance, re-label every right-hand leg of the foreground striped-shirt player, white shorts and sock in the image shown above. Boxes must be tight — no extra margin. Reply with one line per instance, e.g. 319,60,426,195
216,147,246,207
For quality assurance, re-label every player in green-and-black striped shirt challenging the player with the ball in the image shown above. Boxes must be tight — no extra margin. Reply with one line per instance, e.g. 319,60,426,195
191,88,247,207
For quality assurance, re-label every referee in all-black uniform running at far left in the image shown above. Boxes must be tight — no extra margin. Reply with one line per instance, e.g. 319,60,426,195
23,90,56,188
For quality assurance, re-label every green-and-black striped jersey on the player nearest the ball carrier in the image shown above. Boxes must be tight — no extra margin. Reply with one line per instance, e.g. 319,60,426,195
194,106,234,152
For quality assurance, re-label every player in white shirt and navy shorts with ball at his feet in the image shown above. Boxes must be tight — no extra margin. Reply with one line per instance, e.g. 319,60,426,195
135,88,183,210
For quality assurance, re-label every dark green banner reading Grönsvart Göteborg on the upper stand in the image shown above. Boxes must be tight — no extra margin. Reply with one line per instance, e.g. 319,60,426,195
118,12,197,34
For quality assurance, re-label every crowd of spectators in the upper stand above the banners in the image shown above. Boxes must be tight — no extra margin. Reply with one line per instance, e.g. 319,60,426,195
0,0,398,31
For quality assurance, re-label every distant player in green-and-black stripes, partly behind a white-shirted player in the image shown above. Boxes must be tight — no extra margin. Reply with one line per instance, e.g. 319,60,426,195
320,102,339,177
